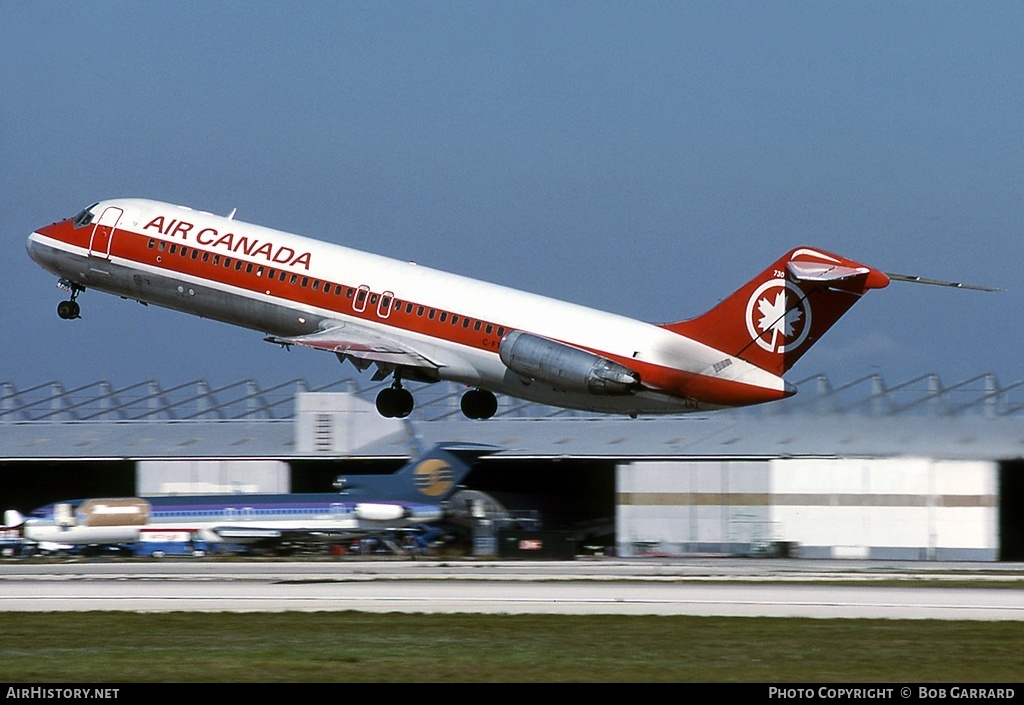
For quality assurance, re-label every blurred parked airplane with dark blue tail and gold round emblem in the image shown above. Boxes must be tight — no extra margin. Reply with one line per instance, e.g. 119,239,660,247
4,443,497,549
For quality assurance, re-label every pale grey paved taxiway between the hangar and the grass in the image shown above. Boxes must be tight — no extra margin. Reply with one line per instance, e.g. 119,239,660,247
0,558,1024,620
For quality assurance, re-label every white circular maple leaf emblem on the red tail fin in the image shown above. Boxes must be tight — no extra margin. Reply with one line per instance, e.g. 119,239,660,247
746,279,811,354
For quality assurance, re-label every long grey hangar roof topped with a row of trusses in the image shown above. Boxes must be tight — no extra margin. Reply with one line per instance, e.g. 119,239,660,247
0,374,1024,461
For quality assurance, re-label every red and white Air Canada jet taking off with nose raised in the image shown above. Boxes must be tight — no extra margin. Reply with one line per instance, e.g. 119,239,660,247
27,199,992,419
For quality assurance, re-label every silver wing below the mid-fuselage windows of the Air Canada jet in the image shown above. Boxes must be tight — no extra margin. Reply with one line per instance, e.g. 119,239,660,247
264,321,443,379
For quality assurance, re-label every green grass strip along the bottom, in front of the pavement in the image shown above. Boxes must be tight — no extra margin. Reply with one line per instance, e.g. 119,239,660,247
0,612,1024,682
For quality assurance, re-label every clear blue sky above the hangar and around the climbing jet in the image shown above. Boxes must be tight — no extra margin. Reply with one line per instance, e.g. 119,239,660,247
0,0,1024,388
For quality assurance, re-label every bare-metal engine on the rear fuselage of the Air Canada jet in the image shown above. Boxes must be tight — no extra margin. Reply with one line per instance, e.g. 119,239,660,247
498,331,640,395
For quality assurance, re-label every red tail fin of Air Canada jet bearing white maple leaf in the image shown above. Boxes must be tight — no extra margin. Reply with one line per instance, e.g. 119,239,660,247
664,247,889,375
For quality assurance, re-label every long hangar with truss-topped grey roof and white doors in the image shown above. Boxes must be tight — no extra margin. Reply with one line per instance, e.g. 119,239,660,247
0,374,1024,561
